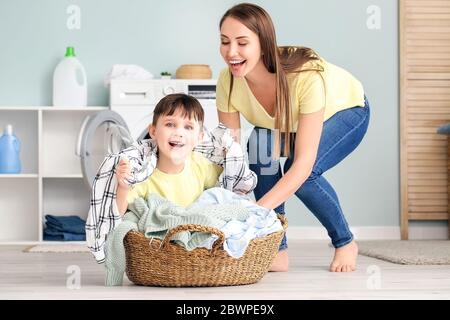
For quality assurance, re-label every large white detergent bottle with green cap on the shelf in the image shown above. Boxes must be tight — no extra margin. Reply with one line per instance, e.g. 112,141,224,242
53,47,87,107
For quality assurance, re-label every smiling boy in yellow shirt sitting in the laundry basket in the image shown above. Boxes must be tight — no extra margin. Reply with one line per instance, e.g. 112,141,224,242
116,94,223,216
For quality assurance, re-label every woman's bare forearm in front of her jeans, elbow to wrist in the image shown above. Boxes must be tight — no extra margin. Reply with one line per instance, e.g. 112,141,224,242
257,162,311,209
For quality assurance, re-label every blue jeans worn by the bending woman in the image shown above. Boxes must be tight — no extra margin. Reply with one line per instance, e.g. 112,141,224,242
247,98,370,250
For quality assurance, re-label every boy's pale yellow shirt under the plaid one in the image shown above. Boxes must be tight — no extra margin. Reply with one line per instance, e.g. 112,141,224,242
127,152,223,207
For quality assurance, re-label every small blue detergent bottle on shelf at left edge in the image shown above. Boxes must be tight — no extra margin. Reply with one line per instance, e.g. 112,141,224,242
0,124,22,173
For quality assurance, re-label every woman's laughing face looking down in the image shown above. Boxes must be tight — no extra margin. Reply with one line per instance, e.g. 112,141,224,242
220,17,263,77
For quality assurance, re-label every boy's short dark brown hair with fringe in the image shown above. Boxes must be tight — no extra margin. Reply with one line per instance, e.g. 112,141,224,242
152,93,205,129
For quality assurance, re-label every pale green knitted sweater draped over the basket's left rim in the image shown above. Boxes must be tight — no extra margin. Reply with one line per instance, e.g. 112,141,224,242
105,194,249,286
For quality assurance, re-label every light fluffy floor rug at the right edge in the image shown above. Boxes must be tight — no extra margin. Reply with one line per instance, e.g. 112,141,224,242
358,240,450,265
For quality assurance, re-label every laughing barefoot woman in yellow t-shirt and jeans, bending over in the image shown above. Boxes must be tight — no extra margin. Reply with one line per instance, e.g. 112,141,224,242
217,3,370,272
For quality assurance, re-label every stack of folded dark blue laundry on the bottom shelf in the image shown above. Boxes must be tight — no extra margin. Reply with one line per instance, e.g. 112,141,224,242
44,214,86,241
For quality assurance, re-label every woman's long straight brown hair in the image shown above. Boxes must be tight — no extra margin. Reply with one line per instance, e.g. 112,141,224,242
219,3,323,158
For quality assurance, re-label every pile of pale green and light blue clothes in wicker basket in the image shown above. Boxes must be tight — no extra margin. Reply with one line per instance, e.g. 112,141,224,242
105,188,283,285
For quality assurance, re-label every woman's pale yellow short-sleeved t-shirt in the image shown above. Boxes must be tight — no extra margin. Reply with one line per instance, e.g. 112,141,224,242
216,59,364,132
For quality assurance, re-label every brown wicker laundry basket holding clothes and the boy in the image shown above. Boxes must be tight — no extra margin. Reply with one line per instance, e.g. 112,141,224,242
124,215,287,287
